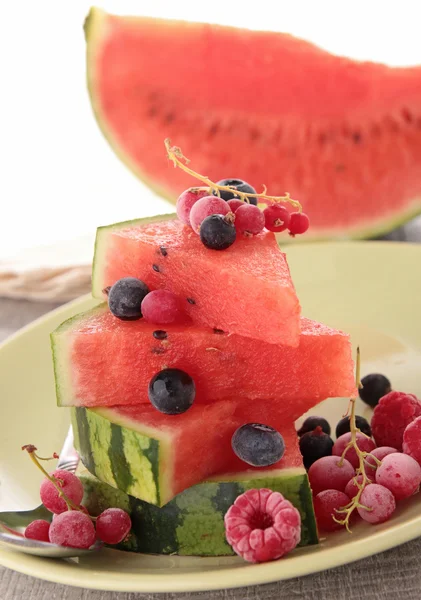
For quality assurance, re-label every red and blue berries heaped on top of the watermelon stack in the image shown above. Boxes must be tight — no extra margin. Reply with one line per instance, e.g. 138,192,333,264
176,179,310,250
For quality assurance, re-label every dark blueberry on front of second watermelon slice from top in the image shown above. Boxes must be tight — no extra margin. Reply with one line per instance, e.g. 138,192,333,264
148,369,196,415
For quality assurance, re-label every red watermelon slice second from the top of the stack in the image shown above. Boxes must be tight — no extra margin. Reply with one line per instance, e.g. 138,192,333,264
52,305,355,420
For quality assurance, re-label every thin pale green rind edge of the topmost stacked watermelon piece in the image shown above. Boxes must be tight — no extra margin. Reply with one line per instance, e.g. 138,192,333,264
92,213,177,300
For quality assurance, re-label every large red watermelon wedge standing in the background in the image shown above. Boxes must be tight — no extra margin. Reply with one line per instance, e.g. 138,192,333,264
86,9,421,240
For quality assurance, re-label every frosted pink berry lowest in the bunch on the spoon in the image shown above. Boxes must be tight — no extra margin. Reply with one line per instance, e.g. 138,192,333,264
50,510,96,548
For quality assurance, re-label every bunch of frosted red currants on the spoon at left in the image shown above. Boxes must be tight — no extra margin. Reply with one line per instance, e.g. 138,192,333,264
23,446,132,549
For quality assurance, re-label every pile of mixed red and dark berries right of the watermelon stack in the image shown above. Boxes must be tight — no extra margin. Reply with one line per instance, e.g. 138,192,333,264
298,382,421,532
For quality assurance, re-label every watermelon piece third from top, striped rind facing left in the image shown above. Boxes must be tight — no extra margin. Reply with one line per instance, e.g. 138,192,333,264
72,400,308,506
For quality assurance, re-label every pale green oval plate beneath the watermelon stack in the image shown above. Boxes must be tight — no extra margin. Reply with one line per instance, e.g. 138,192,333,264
0,242,421,592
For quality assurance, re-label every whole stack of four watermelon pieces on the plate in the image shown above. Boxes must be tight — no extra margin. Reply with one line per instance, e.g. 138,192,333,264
52,215,355,555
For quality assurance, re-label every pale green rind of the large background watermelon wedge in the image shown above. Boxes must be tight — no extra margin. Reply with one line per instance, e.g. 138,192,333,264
85,7,421,245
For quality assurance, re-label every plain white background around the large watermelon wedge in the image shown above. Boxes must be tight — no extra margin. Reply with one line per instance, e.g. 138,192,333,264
0,0,421,259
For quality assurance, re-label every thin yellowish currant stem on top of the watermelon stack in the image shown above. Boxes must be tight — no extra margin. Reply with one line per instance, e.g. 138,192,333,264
164,138,303,212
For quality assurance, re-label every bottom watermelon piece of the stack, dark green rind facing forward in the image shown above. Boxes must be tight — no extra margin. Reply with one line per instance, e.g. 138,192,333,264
80,467,318,556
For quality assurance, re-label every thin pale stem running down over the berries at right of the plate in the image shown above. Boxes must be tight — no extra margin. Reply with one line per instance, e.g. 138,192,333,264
332,348,375,533
